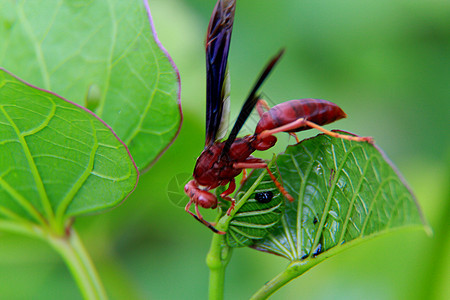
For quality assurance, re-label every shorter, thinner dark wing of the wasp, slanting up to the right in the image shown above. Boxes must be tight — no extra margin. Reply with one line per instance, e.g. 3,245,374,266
221,49,284,156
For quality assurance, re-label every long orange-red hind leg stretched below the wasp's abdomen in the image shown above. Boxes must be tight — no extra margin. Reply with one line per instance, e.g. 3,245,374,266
258,118,374,144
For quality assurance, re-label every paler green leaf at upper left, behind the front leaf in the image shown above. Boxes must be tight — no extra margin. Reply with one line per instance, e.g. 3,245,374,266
0,0,181,170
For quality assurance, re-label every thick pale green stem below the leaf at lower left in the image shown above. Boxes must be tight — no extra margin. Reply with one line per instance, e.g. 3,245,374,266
48,229,107,299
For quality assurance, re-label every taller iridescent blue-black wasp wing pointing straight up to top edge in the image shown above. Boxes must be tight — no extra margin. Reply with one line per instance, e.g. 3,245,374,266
205,0,236,146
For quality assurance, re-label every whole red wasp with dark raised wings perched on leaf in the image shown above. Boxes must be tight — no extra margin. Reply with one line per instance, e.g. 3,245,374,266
184,0,372,234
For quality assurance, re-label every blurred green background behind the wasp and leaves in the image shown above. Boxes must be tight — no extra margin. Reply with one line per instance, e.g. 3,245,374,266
0,0,450,299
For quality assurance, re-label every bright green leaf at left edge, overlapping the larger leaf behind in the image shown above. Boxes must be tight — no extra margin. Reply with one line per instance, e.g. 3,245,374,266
0,69,138,233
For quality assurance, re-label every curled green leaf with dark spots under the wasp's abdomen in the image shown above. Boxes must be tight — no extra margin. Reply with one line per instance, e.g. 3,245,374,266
239,134,424,261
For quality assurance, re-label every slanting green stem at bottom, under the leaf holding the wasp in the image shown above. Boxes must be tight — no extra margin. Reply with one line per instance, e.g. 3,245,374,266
250,259,323,300
